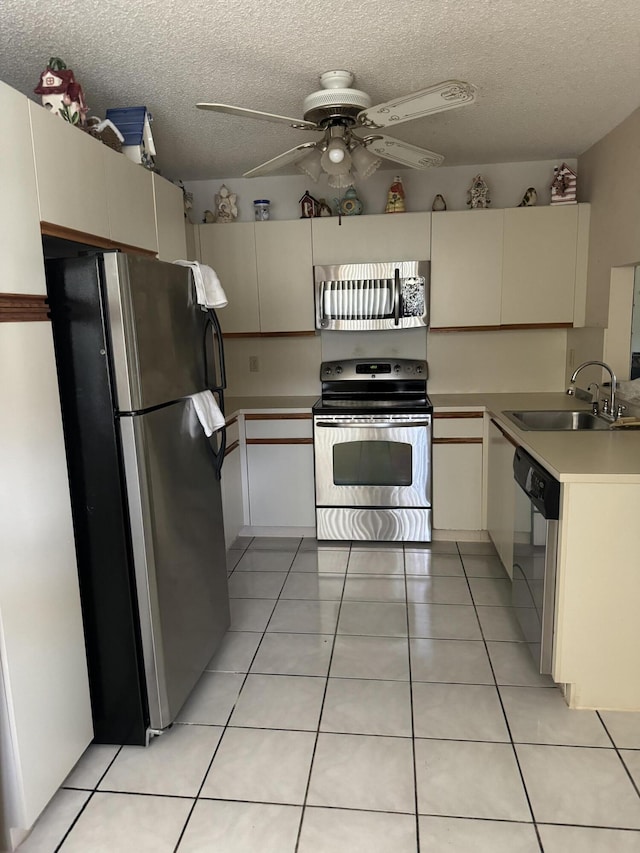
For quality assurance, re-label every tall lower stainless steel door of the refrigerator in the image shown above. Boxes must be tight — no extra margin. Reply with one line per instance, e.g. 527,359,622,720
120,400,229,729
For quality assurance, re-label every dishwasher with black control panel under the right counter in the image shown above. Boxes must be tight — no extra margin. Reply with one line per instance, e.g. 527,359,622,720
511,447,560,675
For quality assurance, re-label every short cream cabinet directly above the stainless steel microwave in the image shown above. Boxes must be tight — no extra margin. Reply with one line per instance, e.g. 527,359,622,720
311,213,431,264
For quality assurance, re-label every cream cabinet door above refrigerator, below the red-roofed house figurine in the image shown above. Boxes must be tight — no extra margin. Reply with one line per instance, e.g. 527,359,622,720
29,101,110,239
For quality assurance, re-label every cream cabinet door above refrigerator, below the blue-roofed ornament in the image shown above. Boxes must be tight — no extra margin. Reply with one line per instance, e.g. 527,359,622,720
104,146,158,252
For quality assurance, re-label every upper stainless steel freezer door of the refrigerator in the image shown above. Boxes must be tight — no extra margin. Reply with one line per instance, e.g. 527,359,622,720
104,252,211,412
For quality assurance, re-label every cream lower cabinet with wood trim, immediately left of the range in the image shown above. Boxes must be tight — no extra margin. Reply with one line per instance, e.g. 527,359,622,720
245,414,315,528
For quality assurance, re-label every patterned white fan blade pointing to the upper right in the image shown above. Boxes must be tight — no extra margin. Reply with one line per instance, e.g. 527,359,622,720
358,80,476,127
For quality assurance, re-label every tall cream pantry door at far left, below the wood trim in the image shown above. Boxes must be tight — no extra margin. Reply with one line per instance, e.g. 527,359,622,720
0,324,93,832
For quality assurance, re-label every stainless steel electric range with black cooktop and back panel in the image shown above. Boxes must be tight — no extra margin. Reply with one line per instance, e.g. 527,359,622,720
313,359,433,542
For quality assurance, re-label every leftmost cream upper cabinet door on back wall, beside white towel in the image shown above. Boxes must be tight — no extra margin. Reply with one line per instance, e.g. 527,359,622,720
198,222,260,332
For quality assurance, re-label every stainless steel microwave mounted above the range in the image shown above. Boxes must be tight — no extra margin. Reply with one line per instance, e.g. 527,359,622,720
314,261,429,331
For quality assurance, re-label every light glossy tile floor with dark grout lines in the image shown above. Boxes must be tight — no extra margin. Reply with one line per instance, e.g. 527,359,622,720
20,539,640,853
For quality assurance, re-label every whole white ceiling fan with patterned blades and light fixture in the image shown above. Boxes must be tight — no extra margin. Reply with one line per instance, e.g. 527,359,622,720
196,71,475,187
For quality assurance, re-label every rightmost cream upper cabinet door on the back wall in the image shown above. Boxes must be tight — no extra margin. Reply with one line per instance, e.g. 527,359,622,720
501,204,578,325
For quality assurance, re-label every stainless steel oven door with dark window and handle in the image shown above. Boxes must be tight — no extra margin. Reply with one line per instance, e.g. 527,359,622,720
314,414,431,508
